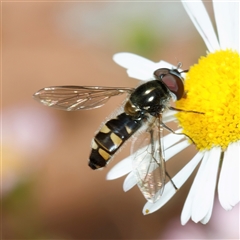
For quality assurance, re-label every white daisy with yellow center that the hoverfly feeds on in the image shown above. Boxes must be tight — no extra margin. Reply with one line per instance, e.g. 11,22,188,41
107,0,240,225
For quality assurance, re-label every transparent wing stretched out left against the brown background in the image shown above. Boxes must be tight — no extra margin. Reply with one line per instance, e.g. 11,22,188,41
33,86,134,111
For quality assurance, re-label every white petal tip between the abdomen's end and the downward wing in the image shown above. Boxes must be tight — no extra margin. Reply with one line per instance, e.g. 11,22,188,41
106,155,132,180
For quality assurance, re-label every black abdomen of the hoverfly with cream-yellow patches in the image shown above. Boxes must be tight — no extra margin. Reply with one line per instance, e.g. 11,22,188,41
88,113,142,169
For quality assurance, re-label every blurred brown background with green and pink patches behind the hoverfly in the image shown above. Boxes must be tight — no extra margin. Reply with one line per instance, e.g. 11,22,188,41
1,1,239,239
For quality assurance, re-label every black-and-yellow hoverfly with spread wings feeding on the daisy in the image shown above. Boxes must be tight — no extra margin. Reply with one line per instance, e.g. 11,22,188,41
33,68,193,202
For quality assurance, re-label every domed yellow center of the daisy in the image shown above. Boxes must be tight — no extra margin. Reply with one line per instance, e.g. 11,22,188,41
176,50,240,150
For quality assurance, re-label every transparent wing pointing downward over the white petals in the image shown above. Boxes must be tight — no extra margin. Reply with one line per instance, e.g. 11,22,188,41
132,118,166,202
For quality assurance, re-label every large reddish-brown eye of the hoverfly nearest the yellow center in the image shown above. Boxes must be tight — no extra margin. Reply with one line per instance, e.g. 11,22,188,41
162,74,184,100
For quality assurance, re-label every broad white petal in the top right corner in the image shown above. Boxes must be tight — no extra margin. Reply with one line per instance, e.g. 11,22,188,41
213,0,239,52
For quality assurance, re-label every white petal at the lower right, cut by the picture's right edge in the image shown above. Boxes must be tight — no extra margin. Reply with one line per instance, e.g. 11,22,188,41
218,142,240,210
